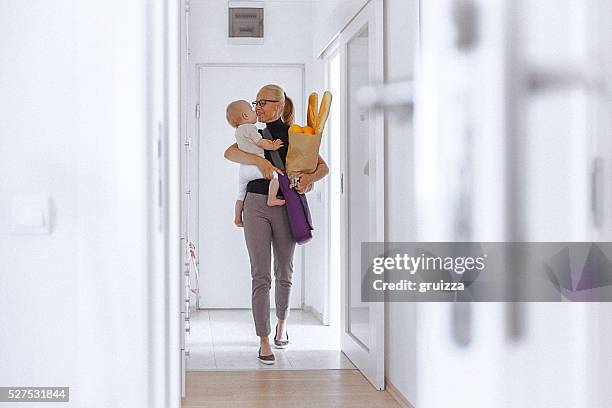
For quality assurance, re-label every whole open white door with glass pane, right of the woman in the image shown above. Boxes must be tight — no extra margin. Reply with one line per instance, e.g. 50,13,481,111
339,1,384,389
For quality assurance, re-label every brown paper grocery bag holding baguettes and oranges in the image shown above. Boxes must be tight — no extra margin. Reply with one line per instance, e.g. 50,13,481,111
286,132,321,177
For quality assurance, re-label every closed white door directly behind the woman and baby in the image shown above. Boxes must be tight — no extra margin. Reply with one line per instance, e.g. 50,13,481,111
197,64,305,308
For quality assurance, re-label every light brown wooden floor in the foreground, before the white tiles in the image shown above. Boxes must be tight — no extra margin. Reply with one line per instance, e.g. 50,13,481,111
182,370,400,408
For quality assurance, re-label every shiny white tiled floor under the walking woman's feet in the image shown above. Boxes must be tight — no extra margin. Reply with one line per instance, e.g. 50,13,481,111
187,310,355,371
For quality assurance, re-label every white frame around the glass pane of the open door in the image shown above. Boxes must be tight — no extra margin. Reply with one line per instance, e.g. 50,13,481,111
322,0,385,390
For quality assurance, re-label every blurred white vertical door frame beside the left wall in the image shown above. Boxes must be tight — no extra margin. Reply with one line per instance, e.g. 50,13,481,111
147,1,184,408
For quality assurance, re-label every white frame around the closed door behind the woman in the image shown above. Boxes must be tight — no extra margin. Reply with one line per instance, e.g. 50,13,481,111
187,62,306,310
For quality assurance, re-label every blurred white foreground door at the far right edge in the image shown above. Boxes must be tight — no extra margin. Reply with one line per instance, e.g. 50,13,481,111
503,0,612,408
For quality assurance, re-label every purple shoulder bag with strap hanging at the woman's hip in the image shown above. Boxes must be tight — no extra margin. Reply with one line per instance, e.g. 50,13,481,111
263,129,314,245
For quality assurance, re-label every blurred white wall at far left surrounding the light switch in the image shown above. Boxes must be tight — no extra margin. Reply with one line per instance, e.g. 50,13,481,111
0,0,158,408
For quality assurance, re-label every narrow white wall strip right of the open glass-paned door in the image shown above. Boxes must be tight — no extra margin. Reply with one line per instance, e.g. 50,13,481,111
385,0,418,404
